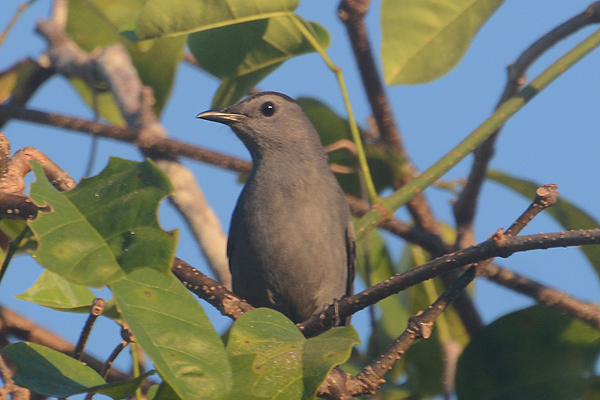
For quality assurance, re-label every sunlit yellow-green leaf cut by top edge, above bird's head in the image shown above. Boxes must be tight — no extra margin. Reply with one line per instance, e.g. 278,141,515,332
122,0,298,40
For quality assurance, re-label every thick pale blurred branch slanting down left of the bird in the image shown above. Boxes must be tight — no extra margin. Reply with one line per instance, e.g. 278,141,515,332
37,20,231,286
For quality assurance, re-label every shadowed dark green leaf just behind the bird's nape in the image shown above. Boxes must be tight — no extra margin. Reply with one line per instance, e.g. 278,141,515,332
297,97,403,197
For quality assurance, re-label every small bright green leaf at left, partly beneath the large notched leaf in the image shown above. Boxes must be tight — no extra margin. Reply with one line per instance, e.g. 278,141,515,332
15,270,96,313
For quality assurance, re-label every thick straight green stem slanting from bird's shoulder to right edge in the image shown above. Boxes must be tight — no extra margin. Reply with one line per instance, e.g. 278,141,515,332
356,25,600,240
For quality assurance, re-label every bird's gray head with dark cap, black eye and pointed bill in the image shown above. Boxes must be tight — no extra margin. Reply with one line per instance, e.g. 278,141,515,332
196,92,321,158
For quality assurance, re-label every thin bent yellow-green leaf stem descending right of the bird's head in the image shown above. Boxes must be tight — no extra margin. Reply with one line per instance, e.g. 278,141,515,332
288,12,379,203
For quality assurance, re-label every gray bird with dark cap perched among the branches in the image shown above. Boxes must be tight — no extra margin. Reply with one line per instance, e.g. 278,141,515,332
197,92,355,324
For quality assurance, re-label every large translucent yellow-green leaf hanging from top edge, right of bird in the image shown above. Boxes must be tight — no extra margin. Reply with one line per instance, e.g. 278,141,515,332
381,0,503,85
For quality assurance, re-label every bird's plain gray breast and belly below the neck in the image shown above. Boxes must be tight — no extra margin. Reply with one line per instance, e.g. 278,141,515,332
228,167,350,322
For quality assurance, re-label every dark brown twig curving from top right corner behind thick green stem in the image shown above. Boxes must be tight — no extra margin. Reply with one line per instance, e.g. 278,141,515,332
453,2,600,249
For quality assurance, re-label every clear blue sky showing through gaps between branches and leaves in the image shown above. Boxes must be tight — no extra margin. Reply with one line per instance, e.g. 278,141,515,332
0,0,600,386
